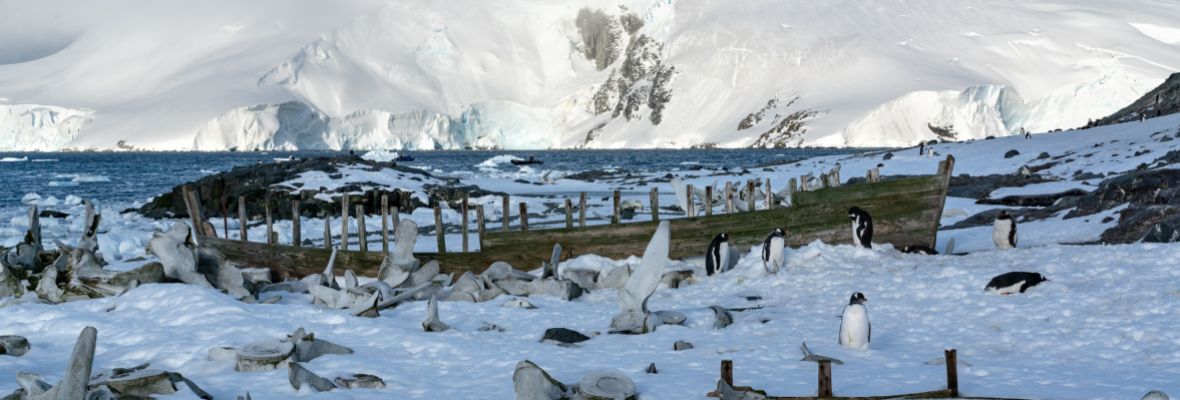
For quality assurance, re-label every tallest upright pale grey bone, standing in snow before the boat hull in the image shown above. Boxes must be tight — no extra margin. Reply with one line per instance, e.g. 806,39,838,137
610,221,671,334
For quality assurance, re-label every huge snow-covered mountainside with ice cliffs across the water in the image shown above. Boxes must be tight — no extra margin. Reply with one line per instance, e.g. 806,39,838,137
0,0,1180,150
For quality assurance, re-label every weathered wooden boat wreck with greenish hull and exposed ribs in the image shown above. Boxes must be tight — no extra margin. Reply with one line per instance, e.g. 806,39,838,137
191,157,955,277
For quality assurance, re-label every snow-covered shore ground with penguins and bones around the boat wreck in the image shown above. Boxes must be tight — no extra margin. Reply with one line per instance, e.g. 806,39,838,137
0,116,1180,399
